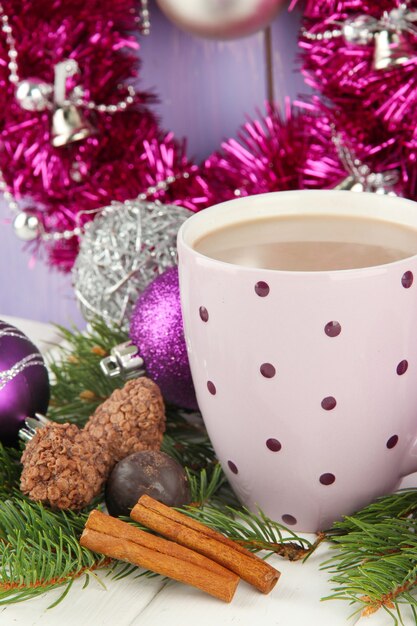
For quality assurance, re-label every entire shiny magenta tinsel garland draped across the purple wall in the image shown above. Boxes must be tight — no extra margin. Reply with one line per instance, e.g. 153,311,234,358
7,0,417,270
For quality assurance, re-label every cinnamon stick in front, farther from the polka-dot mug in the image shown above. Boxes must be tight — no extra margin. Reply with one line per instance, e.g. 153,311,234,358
80,511,239,602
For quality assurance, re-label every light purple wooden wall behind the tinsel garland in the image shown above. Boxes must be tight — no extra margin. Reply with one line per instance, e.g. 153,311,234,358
0,3,306,326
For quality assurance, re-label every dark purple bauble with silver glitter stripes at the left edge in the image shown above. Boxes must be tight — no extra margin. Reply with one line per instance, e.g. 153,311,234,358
0,321,49,445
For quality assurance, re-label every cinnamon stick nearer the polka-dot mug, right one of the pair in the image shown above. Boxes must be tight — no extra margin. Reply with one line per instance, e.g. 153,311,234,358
130,495,280,593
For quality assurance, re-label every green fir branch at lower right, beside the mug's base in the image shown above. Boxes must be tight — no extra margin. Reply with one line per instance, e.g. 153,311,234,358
323,489,417,623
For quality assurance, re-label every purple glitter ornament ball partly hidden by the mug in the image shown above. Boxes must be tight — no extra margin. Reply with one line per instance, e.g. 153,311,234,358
129,267,198,410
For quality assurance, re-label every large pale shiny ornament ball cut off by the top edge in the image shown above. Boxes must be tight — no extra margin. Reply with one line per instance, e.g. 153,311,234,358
157,0,285,39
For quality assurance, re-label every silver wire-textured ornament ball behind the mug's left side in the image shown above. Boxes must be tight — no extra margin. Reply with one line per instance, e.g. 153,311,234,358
73,200,191,330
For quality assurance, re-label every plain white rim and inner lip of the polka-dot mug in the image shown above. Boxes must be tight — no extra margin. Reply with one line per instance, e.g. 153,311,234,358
177,189,417,276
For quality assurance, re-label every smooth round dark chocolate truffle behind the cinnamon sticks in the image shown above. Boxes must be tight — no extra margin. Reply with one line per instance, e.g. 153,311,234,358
106,450,190,517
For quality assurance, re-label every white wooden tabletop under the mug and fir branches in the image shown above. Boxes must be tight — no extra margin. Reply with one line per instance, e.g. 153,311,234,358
0,315,417,626
